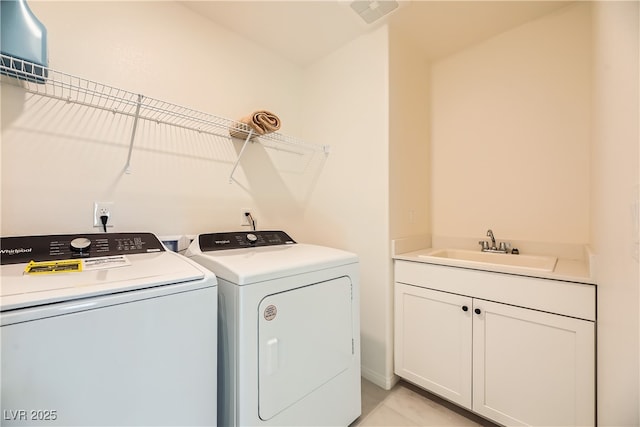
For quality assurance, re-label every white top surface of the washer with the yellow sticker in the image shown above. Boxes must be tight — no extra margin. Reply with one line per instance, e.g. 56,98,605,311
0,236,216,311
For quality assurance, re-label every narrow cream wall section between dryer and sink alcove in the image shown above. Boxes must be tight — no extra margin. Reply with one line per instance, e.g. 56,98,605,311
299,26,393,387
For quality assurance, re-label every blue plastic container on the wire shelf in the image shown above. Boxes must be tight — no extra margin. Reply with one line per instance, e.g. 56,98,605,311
0,0,49,83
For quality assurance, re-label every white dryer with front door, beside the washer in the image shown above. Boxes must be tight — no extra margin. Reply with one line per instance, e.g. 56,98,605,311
186,231,361,426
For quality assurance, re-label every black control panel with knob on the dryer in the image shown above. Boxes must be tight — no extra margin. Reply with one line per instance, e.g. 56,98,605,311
198,231,296,252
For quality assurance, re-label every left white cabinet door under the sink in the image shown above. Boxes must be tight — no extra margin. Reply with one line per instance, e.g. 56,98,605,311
395,283,472,408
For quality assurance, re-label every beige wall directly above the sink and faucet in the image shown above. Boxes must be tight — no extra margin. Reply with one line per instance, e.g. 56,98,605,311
431,3,591,244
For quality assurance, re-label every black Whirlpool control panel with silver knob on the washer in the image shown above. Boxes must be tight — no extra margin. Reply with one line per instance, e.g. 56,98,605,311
0,233,165,265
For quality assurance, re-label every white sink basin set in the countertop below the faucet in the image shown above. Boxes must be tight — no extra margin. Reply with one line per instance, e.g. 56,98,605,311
419,249,558,271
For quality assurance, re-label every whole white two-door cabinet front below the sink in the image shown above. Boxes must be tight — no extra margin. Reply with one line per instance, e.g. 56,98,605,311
395,260,595,426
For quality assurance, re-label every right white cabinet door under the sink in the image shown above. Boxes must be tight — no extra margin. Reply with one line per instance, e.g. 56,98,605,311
473,300,595,426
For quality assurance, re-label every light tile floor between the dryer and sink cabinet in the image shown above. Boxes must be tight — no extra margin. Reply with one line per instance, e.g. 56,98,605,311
350,379,497,427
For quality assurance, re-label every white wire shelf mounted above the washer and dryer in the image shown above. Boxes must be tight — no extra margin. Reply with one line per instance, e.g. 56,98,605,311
0,54,329,177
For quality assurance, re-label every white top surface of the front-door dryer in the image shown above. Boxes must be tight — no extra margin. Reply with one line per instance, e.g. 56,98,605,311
186,238,358,285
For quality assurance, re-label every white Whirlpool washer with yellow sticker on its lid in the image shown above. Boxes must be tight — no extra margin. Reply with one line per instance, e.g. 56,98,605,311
0,233,217,426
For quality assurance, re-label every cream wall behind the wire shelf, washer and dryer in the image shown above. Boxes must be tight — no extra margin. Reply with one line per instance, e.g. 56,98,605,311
1,1,310,235
